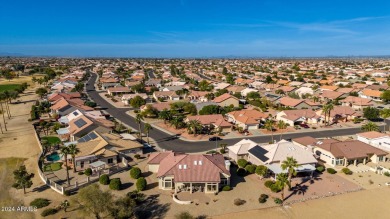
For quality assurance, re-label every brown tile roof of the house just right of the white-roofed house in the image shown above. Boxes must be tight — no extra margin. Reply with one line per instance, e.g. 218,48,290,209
318,140,387,159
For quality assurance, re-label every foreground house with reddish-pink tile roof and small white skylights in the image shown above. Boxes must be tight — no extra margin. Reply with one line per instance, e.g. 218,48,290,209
147,151,231,193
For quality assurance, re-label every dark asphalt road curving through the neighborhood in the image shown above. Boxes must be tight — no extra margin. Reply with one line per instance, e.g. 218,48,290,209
86,73,388,153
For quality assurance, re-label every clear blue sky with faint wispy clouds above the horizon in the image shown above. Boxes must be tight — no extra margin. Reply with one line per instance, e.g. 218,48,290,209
0,0,390,57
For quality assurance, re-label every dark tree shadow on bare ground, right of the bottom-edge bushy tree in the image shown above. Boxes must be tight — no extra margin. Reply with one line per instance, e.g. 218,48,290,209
135,195,171,219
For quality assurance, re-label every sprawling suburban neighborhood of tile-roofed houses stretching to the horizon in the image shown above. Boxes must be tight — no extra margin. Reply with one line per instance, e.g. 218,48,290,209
0,57,390,218
